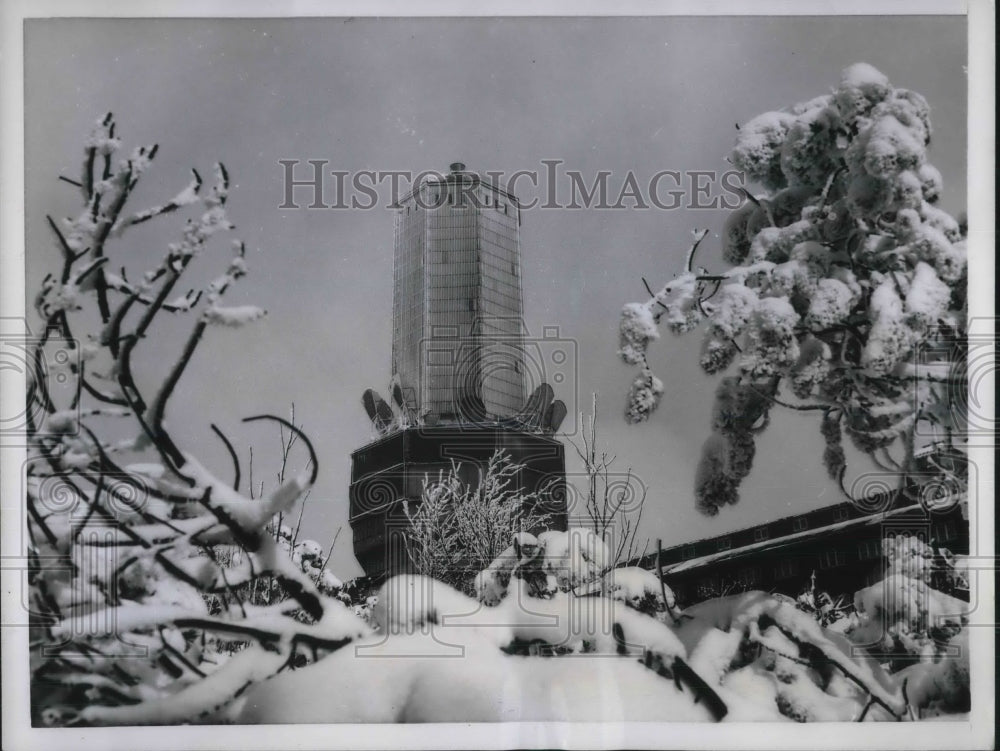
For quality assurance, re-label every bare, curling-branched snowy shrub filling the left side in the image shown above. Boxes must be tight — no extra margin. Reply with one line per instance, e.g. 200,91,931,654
25,114,370,725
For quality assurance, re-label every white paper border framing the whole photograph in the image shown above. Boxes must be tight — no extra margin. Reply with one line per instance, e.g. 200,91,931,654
0,0,996,750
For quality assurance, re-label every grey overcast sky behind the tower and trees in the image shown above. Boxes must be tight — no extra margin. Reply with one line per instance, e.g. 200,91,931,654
25,17,967,577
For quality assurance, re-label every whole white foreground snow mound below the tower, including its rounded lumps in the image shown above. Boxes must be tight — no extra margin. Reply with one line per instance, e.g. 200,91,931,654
238,576,752,723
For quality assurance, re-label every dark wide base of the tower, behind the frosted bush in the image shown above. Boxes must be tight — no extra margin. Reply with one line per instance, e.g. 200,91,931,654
350,423,567,578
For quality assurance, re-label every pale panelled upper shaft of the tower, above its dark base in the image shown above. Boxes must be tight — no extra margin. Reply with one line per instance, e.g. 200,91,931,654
392,163,527,423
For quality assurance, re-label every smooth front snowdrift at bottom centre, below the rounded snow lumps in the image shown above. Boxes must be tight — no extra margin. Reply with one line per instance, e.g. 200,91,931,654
237,628,752,724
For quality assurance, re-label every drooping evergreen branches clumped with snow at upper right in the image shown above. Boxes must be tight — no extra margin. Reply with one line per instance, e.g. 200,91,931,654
620,63,967,514
